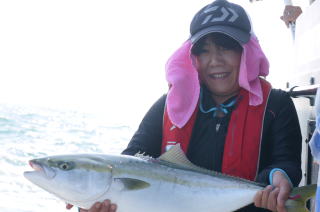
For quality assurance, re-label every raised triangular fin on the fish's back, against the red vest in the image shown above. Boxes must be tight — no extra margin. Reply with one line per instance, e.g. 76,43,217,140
158,144,206,171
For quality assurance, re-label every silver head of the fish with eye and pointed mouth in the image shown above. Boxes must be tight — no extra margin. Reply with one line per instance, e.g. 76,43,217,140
24,155,112,206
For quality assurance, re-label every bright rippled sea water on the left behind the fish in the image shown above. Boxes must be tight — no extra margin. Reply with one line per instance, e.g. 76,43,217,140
0,104,135,212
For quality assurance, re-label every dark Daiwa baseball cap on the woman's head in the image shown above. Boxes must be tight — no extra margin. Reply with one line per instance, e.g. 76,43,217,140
190,0,251,44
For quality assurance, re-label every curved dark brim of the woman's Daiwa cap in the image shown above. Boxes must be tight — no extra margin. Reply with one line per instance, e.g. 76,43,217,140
190,26,250,44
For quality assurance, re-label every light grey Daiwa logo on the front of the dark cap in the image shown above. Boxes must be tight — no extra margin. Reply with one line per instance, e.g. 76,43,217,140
201,5,239,25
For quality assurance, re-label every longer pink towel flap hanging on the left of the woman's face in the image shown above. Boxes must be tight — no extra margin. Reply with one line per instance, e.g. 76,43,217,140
166,40,200,128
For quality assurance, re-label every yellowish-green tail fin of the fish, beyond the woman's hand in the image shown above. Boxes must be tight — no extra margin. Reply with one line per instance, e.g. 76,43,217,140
286,184,317,212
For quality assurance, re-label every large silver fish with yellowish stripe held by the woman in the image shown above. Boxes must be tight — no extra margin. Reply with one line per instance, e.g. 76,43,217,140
24,145,316,212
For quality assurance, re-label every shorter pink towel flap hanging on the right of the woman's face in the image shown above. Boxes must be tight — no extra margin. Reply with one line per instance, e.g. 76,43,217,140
239,35,269,106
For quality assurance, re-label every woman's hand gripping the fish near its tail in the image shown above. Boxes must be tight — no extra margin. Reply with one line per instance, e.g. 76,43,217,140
254,171,292,212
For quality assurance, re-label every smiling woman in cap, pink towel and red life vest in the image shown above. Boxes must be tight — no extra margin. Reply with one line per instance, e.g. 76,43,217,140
67,0,302,212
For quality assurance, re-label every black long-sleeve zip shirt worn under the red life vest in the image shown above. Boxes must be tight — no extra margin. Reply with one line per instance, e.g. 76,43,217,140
123,89,302,211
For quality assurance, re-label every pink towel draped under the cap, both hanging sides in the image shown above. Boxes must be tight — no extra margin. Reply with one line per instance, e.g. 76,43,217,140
166,35,269,128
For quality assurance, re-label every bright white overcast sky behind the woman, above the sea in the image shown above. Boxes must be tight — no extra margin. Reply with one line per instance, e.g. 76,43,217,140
0,0,304,122
